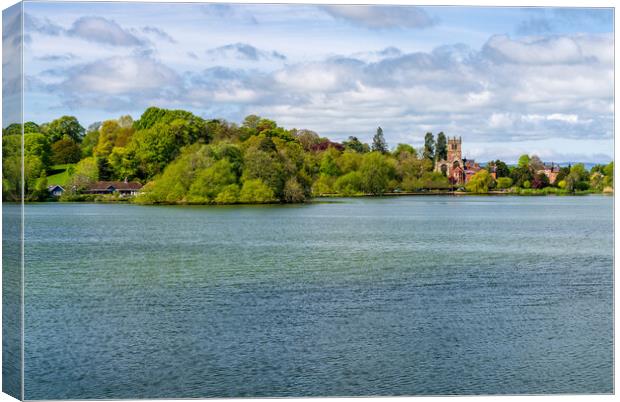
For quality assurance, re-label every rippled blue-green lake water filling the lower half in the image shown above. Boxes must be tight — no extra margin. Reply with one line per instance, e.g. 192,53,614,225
25,196,613,399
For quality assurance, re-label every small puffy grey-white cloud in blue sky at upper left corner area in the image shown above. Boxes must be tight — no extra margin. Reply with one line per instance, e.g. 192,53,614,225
67,17,146,46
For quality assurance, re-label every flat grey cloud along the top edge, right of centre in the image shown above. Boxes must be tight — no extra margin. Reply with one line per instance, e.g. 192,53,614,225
321,5,437,29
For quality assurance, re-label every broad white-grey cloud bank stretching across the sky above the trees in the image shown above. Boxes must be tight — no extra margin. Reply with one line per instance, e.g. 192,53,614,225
27,29,614,157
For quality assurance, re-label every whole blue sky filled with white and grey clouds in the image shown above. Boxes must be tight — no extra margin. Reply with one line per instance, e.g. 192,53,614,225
14,2,614,162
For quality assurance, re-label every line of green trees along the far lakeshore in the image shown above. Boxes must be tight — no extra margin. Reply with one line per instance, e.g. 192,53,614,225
2,107,613,204
